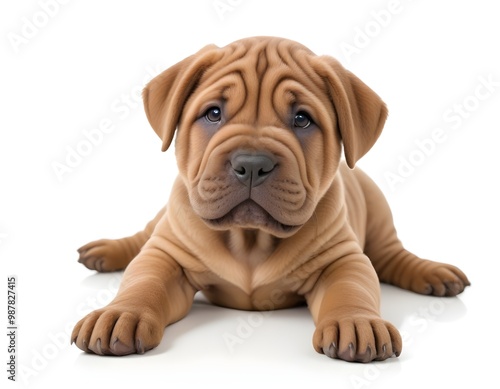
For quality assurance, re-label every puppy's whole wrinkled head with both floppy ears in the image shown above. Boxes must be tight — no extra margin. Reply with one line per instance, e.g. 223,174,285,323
144,37,387,237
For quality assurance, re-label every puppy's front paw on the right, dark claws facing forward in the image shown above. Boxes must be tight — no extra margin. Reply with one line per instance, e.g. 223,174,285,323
313,317,403,362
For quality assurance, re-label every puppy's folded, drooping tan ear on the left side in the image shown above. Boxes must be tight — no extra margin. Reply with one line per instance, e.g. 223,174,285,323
142,45,219,151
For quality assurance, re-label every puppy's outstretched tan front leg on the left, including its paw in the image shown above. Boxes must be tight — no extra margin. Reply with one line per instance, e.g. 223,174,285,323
71,248,196,355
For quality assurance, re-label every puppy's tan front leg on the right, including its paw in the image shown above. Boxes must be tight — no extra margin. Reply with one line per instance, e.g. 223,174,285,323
306,253,402,362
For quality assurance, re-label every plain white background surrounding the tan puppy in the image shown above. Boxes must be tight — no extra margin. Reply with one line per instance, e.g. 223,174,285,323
0,0,500,388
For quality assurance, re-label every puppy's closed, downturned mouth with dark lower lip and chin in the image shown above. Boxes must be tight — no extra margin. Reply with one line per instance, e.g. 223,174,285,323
203,200,301,237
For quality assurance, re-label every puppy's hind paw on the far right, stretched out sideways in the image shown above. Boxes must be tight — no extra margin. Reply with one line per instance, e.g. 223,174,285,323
411,260,470,296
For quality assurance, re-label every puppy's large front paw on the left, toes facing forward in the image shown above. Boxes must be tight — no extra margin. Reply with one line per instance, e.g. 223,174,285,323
71,306,164,356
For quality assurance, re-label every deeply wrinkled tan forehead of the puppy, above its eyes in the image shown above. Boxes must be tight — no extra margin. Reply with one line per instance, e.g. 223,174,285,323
189,38,326,123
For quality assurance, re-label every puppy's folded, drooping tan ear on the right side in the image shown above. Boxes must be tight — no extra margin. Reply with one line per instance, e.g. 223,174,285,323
314,56,387,169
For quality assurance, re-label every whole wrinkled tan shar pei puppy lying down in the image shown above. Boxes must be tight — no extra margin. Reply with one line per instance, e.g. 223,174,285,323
72,37,469,362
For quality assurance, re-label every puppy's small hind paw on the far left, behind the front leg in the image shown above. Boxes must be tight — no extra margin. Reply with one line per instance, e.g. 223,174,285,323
78,239,130,272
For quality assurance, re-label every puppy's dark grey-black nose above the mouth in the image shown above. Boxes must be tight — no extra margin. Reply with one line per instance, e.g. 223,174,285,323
231,153,276,188
